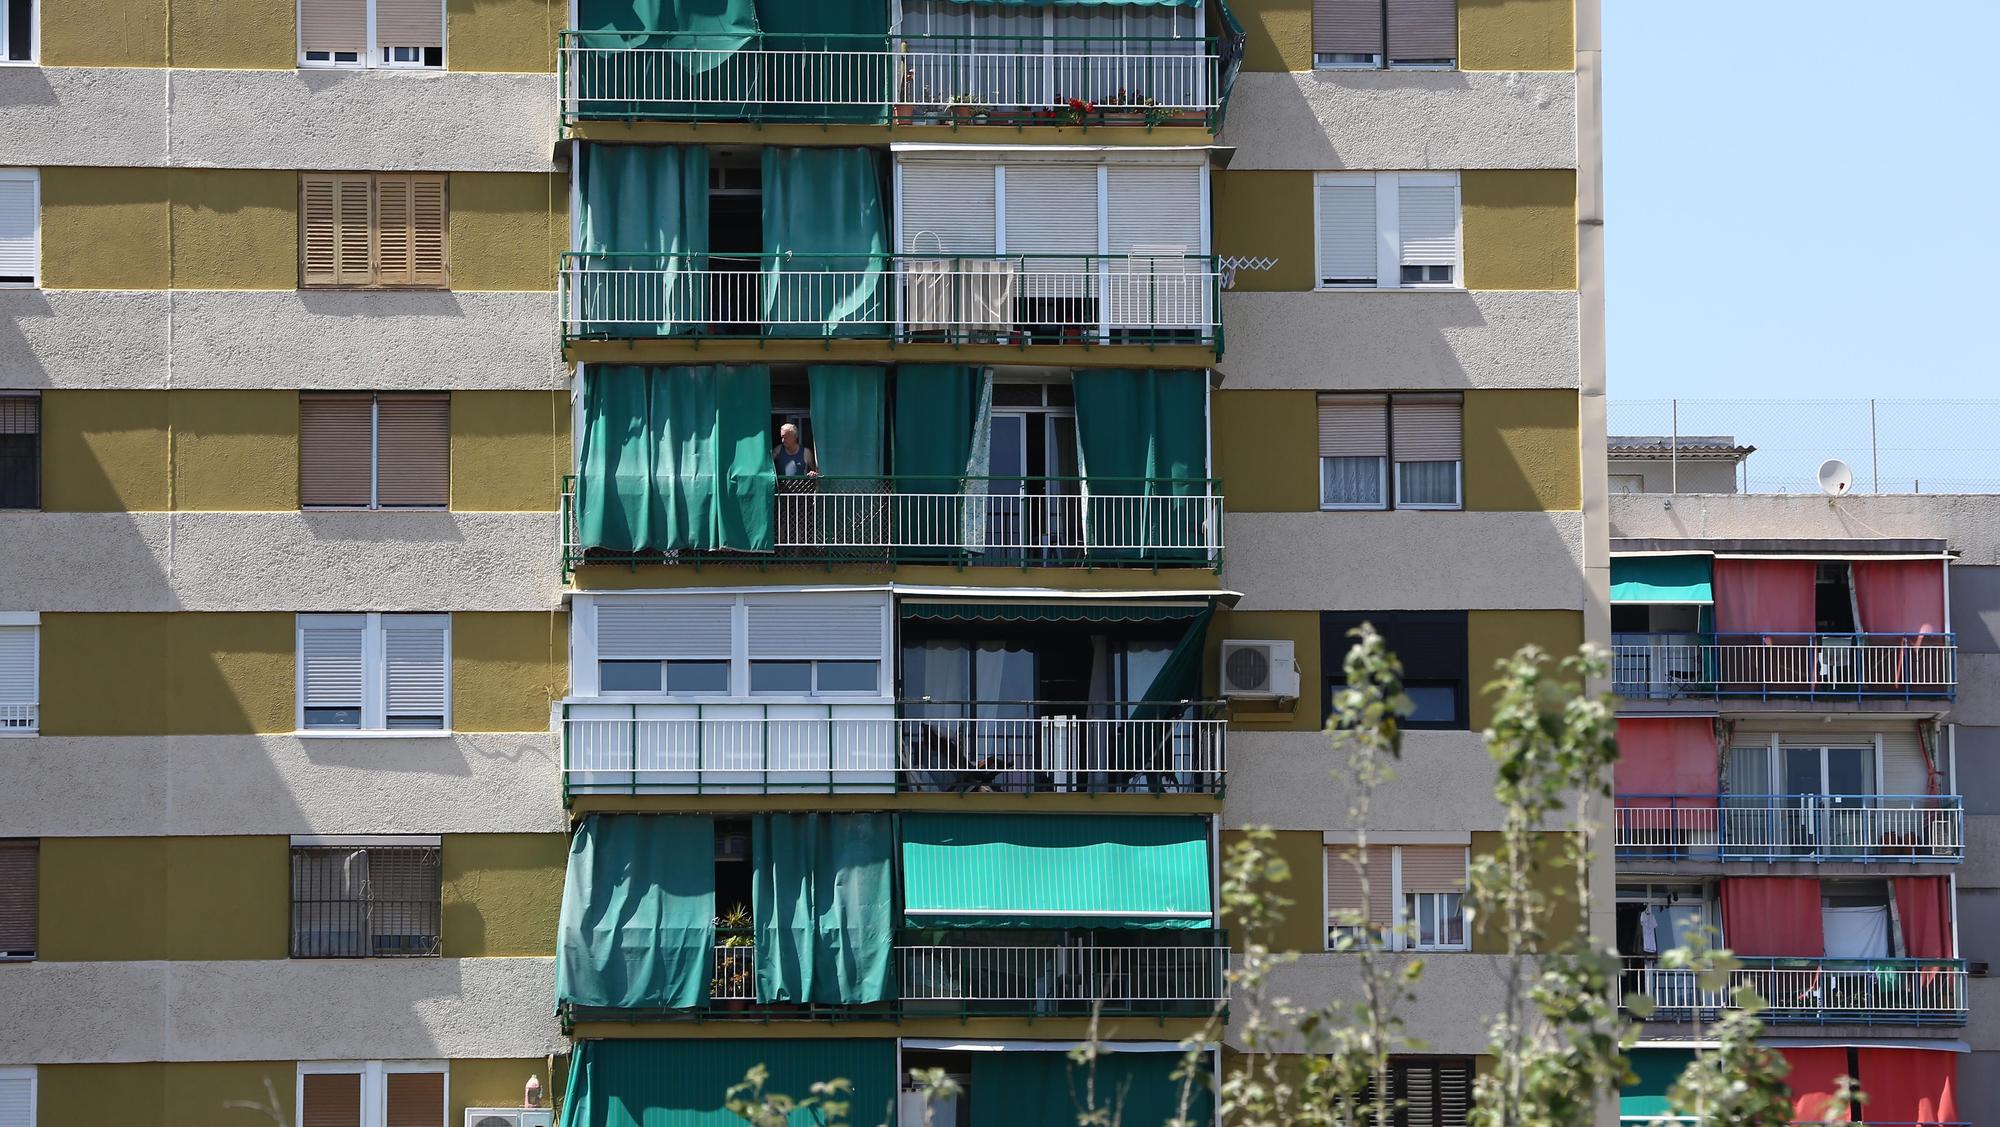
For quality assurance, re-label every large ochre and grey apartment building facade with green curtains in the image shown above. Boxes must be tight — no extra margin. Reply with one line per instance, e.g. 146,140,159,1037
0,0,1612,1127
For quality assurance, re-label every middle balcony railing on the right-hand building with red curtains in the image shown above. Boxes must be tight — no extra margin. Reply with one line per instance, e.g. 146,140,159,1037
1616,795,1966,865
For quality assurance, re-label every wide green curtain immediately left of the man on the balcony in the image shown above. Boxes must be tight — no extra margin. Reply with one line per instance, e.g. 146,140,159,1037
576,364,778,552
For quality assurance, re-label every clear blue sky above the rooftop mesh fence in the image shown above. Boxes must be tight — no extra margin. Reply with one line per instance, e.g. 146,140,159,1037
1604,0,2000,405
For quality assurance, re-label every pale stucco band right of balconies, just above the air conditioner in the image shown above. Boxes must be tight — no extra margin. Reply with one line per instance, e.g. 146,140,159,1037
1222,512,1584,609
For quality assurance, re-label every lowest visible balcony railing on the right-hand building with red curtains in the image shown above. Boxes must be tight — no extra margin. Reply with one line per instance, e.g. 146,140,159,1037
1624,957,1966,1025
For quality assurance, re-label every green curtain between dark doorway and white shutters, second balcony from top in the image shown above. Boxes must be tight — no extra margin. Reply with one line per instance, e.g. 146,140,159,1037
762,148,890,338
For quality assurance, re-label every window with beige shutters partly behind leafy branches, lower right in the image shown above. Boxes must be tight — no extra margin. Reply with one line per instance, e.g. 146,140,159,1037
1326,845,1470,951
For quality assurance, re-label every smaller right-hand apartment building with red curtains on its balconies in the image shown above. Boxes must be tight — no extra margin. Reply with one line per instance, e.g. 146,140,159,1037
1612,489,2000,1123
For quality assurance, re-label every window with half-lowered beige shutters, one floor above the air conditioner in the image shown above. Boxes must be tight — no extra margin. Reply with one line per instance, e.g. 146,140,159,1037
1320,394,1464,510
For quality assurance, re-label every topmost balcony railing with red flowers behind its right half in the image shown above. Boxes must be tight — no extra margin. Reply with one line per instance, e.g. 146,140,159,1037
560,30,1224,132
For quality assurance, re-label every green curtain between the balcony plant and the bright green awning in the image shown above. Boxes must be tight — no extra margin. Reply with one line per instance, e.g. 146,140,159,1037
750,813,896,1005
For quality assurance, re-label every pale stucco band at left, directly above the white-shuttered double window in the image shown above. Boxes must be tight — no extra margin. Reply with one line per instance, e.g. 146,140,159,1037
0,512,564,611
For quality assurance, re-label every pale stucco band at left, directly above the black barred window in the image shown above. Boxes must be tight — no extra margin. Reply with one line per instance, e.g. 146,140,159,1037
0,719,568,837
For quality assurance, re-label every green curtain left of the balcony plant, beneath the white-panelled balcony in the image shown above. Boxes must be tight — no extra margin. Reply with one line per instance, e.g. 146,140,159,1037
556,813,716,1009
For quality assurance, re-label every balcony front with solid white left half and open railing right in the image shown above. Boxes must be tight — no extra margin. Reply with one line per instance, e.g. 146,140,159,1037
562,701,1228,797
